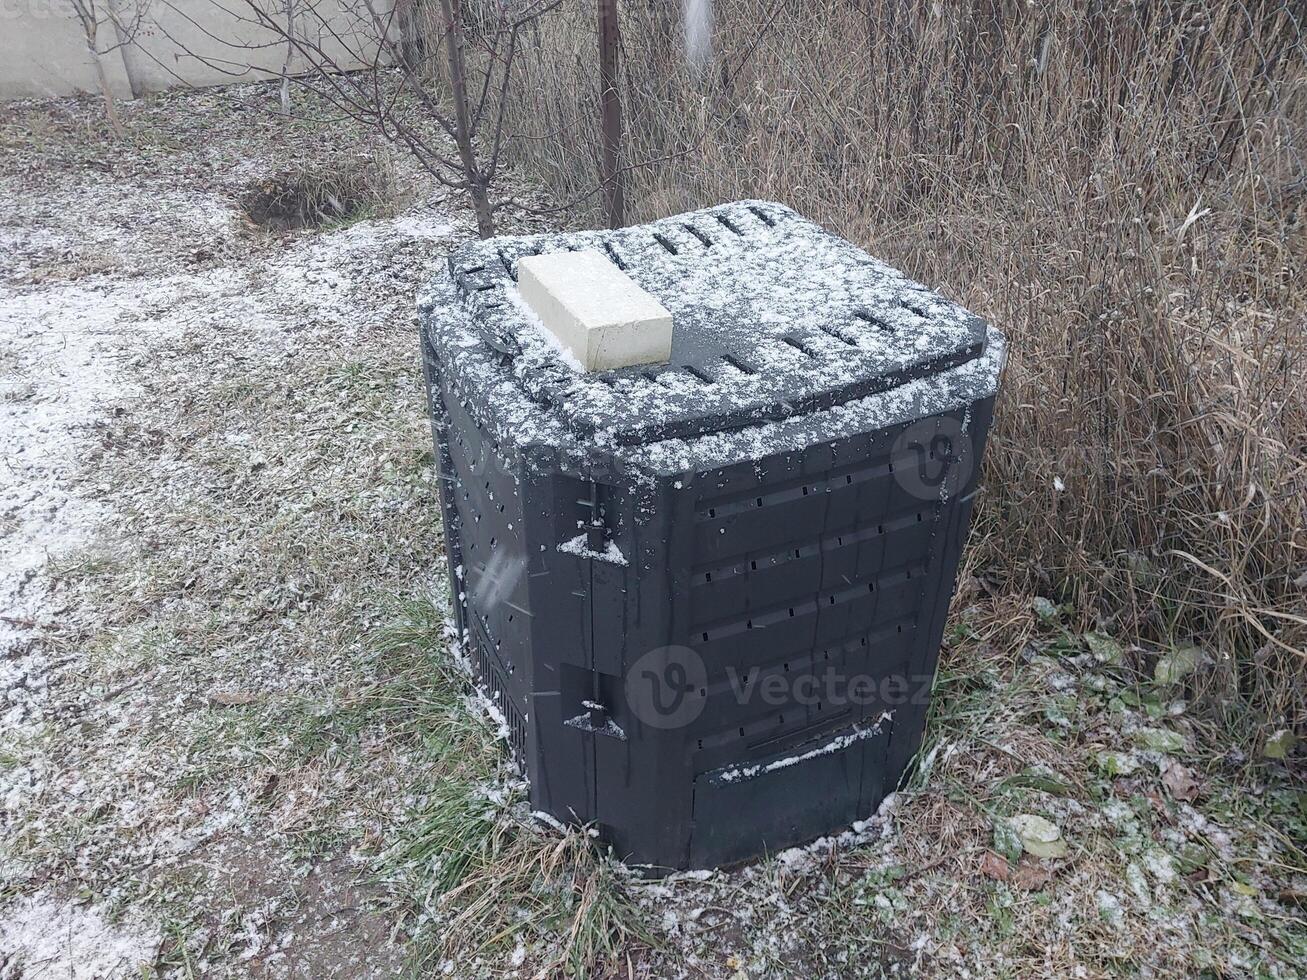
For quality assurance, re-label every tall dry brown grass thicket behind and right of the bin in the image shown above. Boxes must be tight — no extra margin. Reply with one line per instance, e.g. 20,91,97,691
494,0,1307,733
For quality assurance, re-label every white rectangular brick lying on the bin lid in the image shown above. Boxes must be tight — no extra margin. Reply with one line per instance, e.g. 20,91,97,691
518,251,672,371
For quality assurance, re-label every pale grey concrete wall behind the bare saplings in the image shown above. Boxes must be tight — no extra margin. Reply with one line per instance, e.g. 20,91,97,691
0,0,391,101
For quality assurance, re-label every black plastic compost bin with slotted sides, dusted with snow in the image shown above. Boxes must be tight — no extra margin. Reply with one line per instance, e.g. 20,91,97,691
420,201,1004,868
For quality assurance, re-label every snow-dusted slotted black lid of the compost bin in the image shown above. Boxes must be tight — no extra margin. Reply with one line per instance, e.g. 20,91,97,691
448,201,985,446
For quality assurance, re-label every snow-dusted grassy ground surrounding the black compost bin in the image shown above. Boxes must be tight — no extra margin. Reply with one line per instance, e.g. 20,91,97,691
0,88,1307,980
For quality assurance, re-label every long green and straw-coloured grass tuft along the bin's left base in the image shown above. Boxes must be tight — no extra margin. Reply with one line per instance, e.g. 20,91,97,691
371,598,655,977
